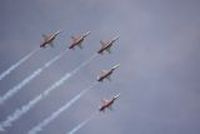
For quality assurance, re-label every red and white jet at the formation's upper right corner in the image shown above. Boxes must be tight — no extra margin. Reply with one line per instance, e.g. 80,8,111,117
97,36,119,54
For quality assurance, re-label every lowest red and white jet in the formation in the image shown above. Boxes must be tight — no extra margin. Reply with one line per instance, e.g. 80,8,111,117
99,94,120,112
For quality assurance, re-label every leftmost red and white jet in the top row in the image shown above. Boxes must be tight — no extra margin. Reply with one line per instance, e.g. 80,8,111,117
40,31,61,48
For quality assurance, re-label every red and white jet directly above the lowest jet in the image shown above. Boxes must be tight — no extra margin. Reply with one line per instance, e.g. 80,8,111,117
97,64,120,82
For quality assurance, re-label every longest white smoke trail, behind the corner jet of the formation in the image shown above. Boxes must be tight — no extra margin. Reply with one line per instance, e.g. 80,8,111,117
0,54,97,131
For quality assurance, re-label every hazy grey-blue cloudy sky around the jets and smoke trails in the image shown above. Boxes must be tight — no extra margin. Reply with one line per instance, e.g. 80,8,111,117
0,0,200,134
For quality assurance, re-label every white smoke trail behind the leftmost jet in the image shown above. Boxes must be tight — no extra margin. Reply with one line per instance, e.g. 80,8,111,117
0,48,39,80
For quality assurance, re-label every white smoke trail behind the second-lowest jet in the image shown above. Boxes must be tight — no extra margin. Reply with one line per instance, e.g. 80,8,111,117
28,82,97,134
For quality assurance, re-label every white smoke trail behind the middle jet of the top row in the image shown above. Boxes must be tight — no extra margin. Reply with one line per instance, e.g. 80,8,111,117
0,51,66,104
